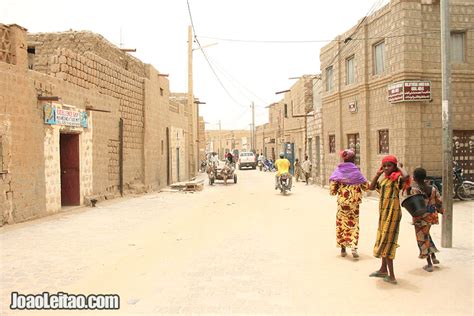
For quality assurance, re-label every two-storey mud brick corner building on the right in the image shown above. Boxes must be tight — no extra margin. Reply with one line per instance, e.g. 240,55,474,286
320,0,474,185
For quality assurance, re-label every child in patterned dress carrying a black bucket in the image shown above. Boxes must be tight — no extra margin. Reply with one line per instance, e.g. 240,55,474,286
408,168,444,272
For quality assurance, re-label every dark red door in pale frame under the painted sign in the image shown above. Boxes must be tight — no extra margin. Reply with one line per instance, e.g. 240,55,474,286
59,134,81,206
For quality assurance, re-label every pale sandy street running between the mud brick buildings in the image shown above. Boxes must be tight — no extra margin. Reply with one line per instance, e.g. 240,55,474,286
0,170,474,315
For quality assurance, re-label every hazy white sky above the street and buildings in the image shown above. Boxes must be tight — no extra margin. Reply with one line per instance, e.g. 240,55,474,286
0,0,388,129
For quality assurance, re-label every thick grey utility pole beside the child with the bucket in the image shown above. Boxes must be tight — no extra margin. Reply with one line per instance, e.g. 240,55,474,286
440,0,453,248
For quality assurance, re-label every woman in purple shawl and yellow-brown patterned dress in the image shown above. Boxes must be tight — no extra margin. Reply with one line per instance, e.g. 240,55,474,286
329,149,369,258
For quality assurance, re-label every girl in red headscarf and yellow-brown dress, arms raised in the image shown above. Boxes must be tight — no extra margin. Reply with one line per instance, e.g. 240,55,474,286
369,156,409,284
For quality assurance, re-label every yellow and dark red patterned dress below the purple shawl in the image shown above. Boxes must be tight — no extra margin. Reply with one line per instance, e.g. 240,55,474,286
329,181,369,249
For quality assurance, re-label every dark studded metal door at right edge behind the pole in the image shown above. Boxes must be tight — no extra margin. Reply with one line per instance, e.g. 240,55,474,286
453,130,474,181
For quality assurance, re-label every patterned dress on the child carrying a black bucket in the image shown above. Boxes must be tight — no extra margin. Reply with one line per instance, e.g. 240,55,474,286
411,183,443,259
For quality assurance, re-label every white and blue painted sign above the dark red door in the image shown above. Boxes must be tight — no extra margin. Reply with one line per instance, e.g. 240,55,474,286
44,104,87,128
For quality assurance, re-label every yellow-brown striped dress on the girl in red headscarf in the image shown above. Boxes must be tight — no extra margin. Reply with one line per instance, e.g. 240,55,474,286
374,176,403,259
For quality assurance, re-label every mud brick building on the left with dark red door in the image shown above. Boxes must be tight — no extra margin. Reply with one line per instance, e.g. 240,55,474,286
0,24,196,225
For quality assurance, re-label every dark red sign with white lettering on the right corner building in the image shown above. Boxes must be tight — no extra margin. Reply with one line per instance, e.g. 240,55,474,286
388,80,431,103
